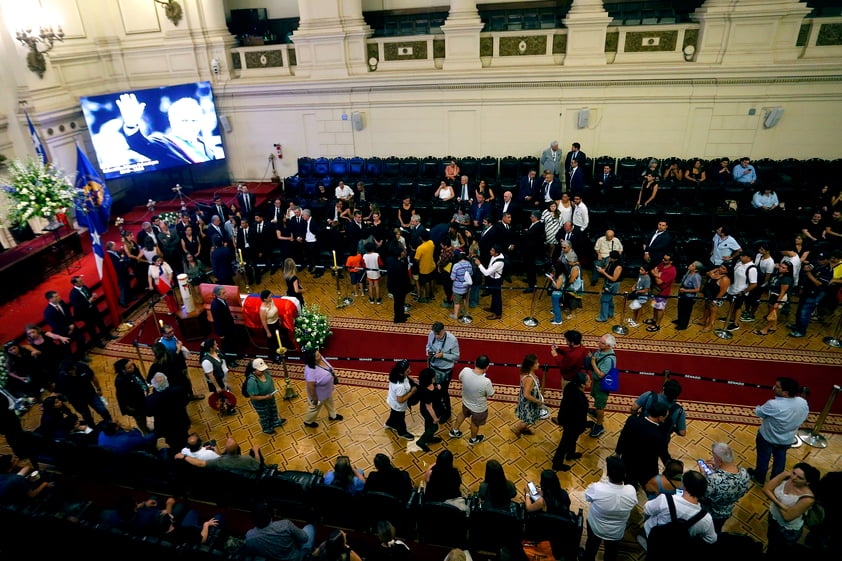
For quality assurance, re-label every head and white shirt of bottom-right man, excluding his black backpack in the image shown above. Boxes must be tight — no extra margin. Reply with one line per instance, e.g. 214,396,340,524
643,471,716,544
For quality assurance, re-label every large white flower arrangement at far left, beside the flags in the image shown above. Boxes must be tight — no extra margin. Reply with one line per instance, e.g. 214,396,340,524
2,158,76,224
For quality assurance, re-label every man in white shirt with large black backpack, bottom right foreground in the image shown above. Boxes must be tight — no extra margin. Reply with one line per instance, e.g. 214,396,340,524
644,468,717,561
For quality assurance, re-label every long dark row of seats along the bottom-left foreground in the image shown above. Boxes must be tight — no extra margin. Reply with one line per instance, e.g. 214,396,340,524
24,434,582,552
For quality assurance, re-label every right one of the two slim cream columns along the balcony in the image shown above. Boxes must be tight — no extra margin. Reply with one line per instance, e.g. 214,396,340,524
563,0,611,66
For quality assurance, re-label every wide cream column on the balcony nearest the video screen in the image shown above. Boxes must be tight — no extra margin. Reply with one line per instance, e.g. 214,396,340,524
292,0,372,79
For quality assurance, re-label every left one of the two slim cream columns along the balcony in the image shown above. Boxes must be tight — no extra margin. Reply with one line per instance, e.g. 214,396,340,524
441,0,483,70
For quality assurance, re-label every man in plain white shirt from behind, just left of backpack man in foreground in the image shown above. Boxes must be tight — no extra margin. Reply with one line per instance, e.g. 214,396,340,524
582,456,637,561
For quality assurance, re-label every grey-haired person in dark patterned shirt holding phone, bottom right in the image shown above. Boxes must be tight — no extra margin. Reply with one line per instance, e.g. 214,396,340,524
699,442,750,534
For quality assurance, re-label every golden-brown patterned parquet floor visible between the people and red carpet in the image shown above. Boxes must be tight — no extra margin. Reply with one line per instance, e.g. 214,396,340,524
0,272,842,559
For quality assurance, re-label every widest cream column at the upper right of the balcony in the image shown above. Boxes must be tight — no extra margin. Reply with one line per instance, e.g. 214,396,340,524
693,0,810,64
